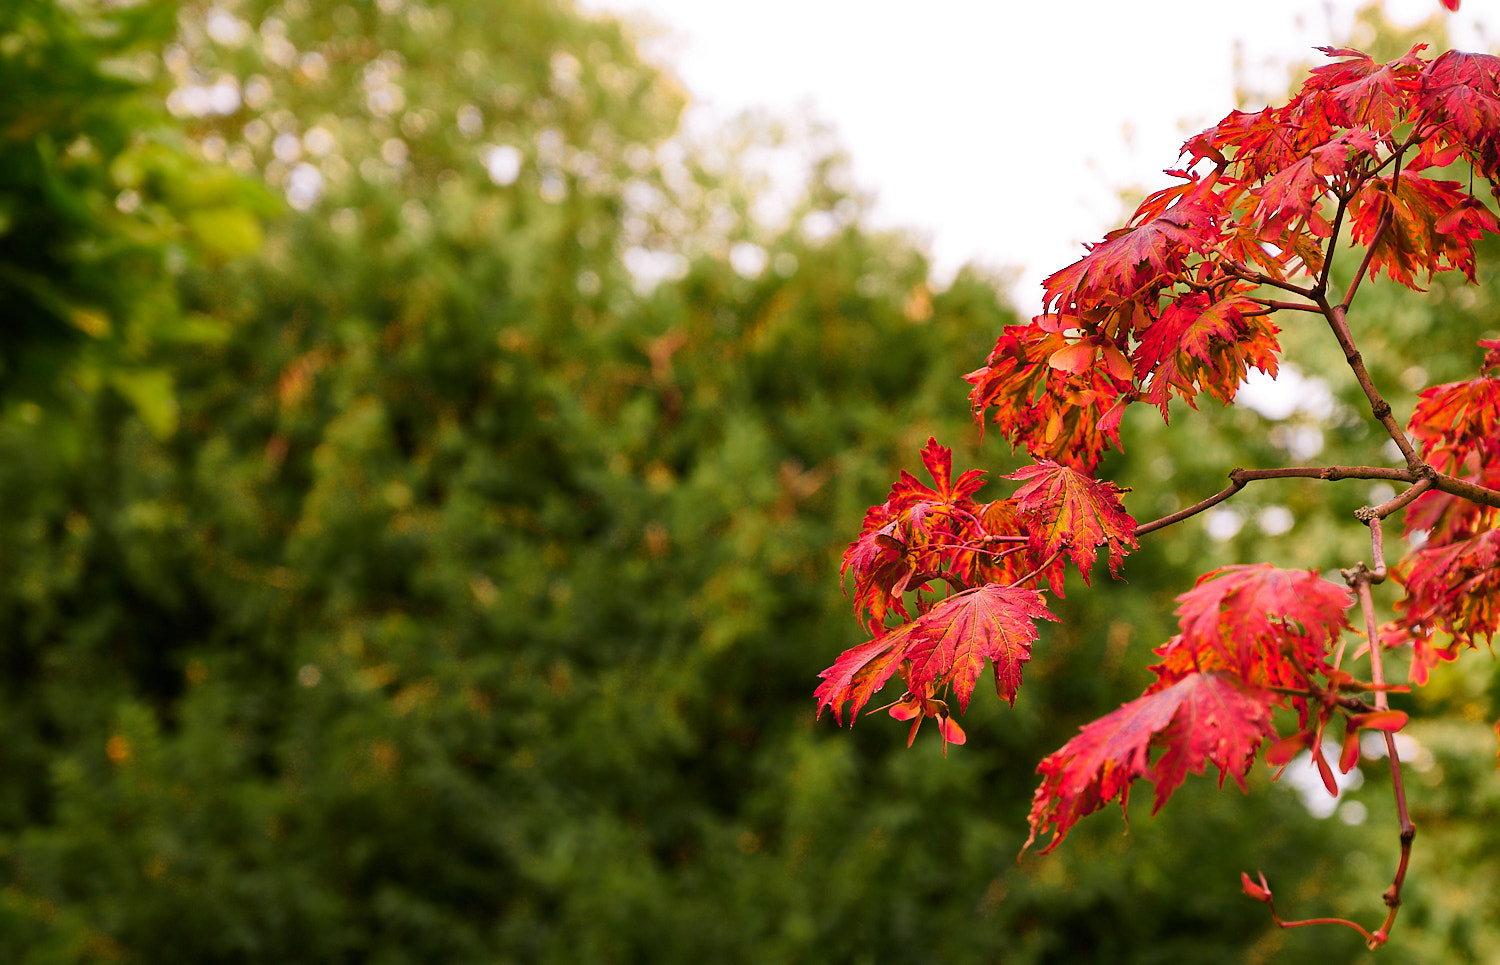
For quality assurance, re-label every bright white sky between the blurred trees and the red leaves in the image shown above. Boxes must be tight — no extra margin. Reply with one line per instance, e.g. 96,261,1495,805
581,0,1497,312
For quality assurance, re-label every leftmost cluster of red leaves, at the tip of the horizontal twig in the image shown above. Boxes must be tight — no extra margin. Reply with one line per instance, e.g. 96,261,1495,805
816,440,1136,743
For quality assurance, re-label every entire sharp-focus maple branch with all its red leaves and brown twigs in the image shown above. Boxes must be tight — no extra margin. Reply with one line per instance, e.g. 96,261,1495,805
816,45,1500,947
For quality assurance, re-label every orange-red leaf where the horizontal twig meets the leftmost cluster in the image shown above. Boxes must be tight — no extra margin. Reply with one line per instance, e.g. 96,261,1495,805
1007,459,1137,591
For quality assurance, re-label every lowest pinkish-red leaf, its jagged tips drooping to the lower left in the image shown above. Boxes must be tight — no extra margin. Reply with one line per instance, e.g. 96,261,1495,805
1026,672,1275,854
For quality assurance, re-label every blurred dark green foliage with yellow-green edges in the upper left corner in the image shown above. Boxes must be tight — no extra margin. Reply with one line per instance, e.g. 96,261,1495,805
0,0,275,435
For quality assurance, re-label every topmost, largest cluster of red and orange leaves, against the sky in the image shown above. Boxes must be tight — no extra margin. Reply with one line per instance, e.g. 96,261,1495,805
966,47,1500,471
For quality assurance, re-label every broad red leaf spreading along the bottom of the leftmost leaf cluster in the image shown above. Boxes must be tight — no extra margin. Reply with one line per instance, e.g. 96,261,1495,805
813,584,1056,723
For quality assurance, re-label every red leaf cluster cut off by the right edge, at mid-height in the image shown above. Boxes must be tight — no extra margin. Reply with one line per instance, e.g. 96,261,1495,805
1382,341,1500,686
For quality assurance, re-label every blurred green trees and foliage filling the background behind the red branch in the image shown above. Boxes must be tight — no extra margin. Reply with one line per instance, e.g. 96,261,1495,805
0,0,1500,963
